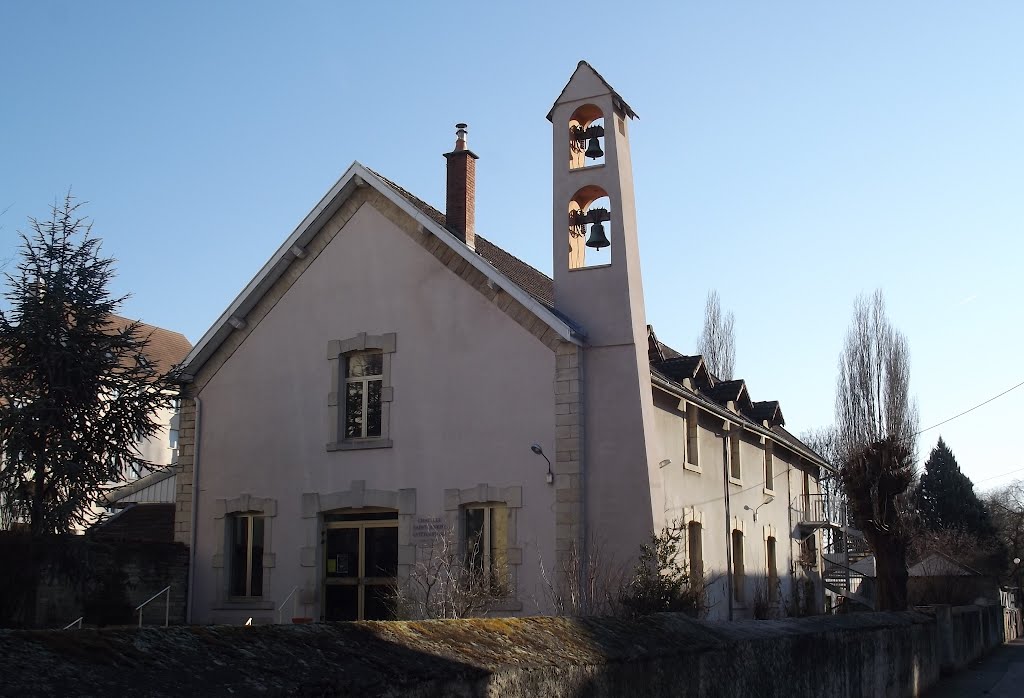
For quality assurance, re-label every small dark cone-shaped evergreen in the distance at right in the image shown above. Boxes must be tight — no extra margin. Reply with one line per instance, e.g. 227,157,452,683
915,436,995,538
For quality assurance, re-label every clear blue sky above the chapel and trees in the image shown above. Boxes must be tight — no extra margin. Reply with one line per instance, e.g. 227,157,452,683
0,0,1024,489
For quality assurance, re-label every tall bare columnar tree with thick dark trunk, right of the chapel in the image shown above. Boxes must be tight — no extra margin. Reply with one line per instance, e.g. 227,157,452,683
836,290,918,610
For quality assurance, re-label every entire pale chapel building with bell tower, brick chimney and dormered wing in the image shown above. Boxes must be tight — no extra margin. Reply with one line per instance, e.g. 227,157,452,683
175,62,826,623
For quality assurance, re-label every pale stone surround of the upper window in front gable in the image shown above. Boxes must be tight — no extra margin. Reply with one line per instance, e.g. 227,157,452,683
327,332,395,451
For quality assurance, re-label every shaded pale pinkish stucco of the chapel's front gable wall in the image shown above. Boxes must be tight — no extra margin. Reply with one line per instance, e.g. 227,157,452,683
194,205,555,622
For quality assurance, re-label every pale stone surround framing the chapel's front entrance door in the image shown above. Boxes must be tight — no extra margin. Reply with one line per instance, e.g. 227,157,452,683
299,480,416,615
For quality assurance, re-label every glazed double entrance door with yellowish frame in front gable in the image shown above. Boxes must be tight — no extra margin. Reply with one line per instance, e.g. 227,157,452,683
321,512,398,620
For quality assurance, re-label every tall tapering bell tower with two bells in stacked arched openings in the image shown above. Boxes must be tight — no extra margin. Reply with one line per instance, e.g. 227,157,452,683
548,61,663,560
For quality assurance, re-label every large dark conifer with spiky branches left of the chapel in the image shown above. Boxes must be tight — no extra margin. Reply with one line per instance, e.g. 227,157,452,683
0,194,174,537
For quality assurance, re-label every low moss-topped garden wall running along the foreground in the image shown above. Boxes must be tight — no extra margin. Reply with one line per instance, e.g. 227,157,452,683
0,607,1002,698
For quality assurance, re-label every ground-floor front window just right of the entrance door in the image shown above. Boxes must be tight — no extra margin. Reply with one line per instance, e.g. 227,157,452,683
463,503,509,597
